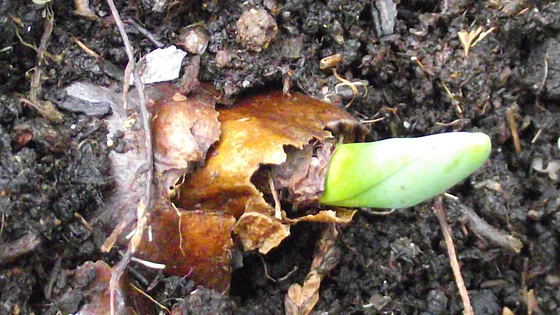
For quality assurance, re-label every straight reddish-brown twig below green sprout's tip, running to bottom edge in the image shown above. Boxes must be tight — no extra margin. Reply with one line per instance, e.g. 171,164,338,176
434,196,474,315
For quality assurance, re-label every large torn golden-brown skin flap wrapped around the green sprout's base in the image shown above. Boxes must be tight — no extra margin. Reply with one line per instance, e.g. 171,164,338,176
176,91,367,253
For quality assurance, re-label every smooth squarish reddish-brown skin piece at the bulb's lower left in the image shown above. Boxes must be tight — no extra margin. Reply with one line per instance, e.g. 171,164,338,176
135,204,235,293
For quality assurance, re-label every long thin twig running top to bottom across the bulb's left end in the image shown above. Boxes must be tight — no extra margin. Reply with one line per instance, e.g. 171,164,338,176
107,0,154,315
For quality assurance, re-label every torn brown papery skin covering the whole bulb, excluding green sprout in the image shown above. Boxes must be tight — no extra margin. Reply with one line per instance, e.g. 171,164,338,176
95,85,367,308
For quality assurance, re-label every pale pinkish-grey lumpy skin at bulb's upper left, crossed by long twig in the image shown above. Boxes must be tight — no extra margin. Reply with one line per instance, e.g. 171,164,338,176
102,83,220,251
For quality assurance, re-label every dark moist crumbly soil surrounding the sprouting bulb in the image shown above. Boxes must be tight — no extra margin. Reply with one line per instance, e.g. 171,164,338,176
0,0,560,314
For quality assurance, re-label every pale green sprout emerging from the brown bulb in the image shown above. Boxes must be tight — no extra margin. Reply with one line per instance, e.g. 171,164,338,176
319,132,491,208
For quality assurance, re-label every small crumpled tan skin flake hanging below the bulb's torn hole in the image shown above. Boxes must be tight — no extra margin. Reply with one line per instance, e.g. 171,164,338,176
233,212,290,254
